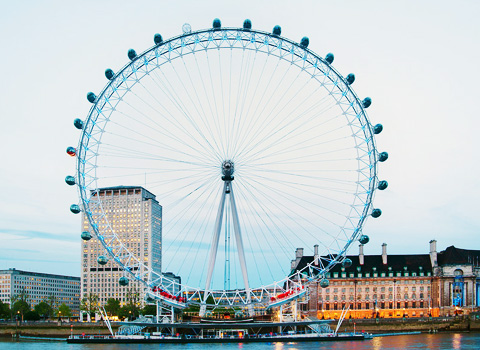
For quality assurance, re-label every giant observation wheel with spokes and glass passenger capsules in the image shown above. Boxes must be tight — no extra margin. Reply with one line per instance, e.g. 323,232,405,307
66,19,388,311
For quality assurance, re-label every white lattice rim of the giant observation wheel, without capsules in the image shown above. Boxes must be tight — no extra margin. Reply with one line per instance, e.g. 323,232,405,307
76,24,378,305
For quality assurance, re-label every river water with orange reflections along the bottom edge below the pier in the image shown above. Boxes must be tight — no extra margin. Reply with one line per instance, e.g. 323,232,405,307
0,333,480,350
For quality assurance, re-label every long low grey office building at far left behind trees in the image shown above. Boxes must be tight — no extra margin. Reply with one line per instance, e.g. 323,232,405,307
0,268,80,317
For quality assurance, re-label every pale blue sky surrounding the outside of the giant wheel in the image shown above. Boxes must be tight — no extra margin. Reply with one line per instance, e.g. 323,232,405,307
0,0,480,276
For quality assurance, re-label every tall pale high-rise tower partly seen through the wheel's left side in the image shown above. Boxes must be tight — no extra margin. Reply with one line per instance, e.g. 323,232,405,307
81,186,162,305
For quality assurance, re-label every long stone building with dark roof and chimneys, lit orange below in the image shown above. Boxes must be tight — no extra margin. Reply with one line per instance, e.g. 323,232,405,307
292,240,480,319
